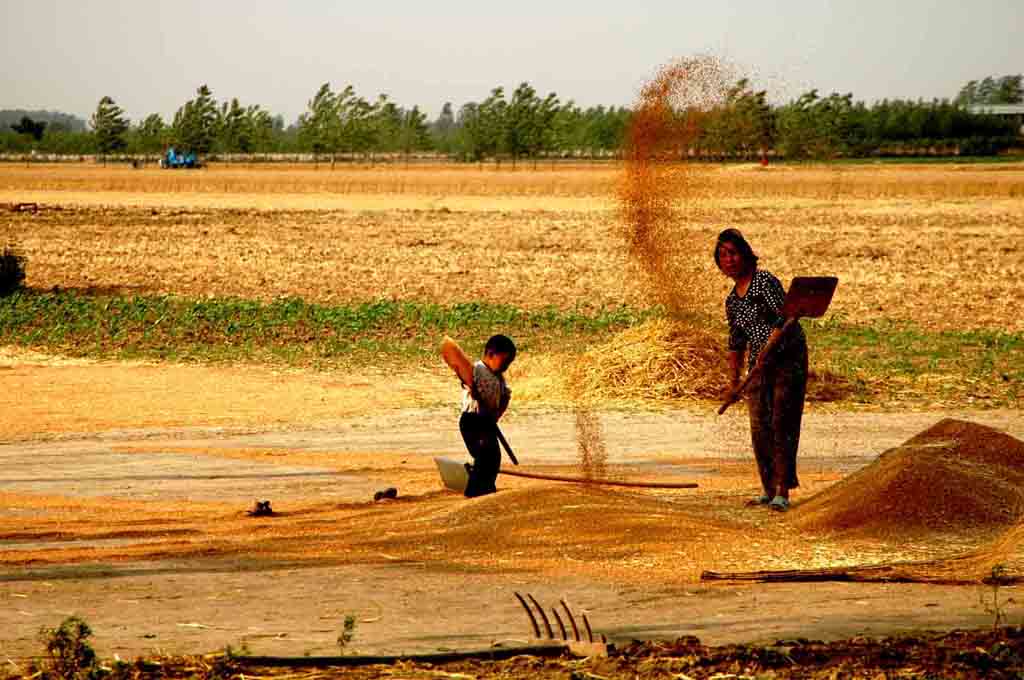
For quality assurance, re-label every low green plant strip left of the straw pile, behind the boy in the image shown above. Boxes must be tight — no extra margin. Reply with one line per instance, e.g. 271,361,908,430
0,290,652,366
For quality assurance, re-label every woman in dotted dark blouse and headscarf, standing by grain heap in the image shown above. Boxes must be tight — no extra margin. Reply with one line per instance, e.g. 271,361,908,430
715,229,807,512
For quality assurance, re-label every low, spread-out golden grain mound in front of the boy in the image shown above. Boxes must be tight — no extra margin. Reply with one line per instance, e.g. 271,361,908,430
411,484,745,581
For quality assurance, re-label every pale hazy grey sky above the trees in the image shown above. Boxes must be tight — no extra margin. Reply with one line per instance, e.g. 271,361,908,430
0,0,1024,123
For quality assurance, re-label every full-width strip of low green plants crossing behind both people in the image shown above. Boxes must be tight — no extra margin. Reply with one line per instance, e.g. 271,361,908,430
0,289,1024,407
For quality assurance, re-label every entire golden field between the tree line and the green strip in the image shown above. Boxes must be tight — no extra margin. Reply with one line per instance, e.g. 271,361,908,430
0,165,1024,332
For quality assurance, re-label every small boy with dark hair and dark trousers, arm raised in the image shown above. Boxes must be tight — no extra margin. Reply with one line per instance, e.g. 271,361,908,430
441,335,515,498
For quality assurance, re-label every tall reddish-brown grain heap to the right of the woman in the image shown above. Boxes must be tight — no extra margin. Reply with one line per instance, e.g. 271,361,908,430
795,419,1024,540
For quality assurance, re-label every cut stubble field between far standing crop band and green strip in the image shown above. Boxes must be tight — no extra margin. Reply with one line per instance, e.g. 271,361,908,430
0,168,1024,332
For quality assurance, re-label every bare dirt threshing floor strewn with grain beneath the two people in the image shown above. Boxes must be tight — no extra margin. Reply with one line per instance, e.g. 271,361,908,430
0,356,1024,657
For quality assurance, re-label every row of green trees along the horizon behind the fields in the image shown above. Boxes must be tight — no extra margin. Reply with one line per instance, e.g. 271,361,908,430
0,76,1024,163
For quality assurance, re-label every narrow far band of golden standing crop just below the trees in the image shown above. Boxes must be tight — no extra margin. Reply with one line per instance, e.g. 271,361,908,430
0,163,1024,201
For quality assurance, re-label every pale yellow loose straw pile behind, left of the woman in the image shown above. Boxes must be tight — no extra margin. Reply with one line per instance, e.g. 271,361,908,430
568,318,728,403
